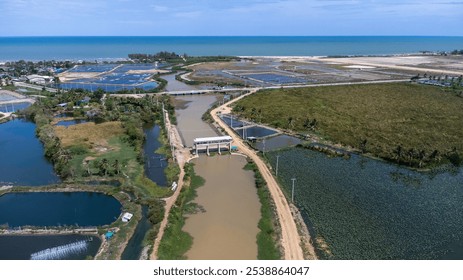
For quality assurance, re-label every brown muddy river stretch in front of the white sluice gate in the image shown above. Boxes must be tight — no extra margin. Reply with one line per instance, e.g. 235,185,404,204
183,155,260,260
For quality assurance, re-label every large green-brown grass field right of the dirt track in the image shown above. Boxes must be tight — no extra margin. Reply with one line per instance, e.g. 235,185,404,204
234,83,463,166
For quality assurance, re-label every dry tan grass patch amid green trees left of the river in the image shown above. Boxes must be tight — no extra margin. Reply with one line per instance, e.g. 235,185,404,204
55,122,124,150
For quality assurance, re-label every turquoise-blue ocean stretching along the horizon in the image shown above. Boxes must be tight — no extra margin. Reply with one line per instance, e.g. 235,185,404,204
0,36,463,62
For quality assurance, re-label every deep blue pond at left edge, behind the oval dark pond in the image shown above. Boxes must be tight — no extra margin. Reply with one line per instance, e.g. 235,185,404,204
0,119,60,186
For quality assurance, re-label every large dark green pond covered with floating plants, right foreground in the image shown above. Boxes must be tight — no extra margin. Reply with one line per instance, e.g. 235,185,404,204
267,148,463,259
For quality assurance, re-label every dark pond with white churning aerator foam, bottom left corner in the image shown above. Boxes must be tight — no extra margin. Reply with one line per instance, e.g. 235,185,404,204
0,234,101,260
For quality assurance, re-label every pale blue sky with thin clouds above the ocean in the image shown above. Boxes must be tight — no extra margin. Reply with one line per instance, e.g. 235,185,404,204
0,0,463,36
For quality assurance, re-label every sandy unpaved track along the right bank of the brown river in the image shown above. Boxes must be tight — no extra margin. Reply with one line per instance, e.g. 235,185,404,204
211,90,315,260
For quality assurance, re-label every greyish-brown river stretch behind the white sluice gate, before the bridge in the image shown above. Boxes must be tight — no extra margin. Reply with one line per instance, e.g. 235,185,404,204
175,95,223,147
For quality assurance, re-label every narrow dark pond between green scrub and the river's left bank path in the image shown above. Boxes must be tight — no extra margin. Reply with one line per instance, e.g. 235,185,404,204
143,125,167,187
